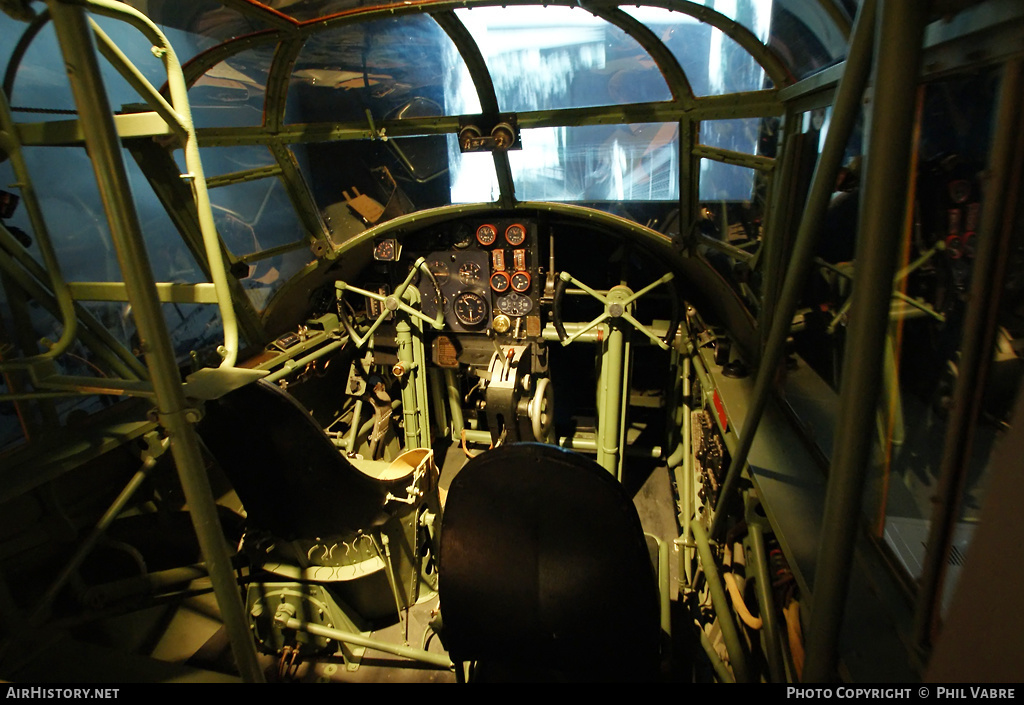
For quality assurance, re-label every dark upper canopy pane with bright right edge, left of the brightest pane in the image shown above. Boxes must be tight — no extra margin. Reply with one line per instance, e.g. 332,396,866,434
286,15,480,123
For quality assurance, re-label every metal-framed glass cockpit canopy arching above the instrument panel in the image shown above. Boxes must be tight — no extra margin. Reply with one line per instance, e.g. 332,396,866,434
0,0,856,450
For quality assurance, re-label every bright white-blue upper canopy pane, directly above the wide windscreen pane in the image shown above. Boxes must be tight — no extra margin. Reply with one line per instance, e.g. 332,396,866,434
456,6,672,112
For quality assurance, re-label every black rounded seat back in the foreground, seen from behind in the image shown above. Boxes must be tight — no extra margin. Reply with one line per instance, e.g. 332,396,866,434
438,444,660,681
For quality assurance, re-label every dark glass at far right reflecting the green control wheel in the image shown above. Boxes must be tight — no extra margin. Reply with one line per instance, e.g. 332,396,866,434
879,72,1024,603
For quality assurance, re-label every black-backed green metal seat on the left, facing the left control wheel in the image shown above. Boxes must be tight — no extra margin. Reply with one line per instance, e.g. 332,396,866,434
199,381,437,653
